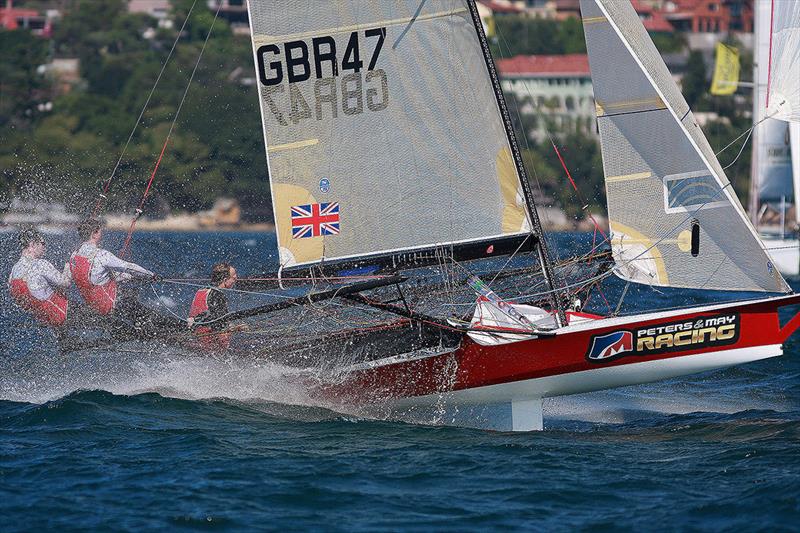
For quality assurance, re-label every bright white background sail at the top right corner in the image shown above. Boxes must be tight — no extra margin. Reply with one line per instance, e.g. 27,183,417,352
757,0,800,122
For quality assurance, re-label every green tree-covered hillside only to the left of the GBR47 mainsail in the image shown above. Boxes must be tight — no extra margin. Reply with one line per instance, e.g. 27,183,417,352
0,0,269,218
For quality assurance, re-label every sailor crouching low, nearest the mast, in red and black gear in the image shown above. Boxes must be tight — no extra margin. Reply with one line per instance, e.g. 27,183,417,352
188,263,242,351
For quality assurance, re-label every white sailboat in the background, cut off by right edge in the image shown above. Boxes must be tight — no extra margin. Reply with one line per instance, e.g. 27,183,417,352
749,0,800,276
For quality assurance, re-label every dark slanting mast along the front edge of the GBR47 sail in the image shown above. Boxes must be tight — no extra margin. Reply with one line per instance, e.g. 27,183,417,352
467,0,566,326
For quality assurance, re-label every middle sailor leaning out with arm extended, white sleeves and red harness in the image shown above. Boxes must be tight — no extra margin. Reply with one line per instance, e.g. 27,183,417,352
69,218,158,315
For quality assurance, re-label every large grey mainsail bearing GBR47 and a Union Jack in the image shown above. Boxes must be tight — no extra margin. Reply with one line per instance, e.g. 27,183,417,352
244,0,531,267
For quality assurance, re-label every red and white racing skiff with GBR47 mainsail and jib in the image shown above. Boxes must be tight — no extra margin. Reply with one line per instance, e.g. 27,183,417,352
236,0,800,431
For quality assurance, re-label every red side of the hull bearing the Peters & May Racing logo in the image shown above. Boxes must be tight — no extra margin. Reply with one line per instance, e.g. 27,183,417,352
324,295,800,403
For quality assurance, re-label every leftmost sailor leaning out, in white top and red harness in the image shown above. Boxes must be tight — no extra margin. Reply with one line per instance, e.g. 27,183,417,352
8,228,70,326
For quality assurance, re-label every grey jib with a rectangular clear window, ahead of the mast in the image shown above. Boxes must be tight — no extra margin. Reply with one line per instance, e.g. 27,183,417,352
581,0,789,292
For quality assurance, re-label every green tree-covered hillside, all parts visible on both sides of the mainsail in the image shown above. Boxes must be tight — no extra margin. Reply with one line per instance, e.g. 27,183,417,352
0,0,750,222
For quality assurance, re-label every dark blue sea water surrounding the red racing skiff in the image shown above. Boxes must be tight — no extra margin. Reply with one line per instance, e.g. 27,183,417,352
0,233,800,531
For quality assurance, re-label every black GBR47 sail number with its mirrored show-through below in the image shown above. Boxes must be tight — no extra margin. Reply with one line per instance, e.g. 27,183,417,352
256,28,389,126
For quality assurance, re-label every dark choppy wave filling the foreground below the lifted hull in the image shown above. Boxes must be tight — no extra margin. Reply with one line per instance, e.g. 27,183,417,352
0,390,800,531
